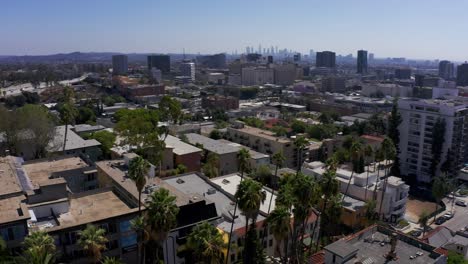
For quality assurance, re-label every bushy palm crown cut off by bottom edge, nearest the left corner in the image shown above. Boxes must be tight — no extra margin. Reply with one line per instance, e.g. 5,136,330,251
23,231,56,264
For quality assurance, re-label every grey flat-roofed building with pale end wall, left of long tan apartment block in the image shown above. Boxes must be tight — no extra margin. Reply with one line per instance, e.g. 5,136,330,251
185,133,239,175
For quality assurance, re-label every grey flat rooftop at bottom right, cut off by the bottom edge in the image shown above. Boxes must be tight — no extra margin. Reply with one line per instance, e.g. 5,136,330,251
325,226,441,264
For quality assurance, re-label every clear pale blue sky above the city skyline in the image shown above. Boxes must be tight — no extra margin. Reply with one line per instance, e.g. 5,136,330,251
0,0,468,61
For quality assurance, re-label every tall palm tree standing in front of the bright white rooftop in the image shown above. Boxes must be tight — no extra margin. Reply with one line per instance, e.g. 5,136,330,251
235,179,266,263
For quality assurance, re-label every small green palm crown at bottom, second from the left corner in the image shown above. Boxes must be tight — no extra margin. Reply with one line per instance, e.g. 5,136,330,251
78,225,108,263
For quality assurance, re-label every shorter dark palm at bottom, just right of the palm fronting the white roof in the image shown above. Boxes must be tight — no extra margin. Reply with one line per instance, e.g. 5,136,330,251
267,206,291,263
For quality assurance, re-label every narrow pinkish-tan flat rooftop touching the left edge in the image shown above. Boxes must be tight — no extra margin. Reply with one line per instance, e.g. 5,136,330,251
0,156,22,196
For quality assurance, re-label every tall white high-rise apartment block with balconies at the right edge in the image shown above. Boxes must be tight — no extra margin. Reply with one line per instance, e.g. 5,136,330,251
398,98,468,183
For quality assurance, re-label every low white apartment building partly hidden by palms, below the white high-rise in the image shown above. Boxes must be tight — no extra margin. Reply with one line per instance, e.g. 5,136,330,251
301,161,409,220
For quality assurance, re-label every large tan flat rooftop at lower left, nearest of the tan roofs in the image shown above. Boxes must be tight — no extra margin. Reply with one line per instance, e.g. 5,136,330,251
56,190,138,229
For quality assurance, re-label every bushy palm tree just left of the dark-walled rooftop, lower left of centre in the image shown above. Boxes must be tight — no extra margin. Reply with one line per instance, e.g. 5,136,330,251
145,188,179,262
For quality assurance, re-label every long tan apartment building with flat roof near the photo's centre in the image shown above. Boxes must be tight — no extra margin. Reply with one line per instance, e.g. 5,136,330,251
226,124,298,168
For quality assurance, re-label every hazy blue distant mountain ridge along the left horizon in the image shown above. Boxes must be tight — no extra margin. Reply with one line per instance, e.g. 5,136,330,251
0,52,203,63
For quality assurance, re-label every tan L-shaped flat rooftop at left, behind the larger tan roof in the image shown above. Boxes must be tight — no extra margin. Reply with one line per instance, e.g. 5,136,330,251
23,157,89,187
